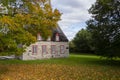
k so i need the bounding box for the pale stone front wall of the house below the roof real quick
[21,41,69,60]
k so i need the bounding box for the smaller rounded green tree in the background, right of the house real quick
[73,29,92,53]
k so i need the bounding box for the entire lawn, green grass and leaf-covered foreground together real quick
[0,54,120,80]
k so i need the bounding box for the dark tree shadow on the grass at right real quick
[72,57,120,67]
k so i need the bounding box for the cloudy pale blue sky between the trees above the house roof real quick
[51,0,96,40]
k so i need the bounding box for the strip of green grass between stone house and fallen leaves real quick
[0,54,120,66]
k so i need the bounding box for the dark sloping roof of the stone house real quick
[52,26,68,42]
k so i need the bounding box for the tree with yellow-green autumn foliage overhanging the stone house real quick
[0,0,61,55]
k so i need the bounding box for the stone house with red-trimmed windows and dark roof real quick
[21,26,69,60]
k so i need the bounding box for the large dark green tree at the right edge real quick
[87,0,120,58]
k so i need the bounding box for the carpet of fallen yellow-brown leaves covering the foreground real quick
[0,64,120,80]
